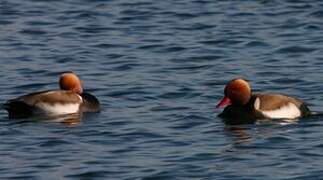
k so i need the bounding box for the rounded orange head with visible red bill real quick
[217,78,251,107]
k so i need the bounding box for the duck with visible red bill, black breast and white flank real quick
[217,78,310,124]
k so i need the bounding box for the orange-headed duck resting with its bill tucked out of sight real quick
[3,72,100,118]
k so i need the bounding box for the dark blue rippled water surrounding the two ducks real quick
[0,0,323,180]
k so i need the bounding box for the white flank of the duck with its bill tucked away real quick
[36,103,80,114]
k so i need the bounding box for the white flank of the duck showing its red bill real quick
[260,103,301,119]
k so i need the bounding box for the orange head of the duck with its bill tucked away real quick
[59,72,83,94]
